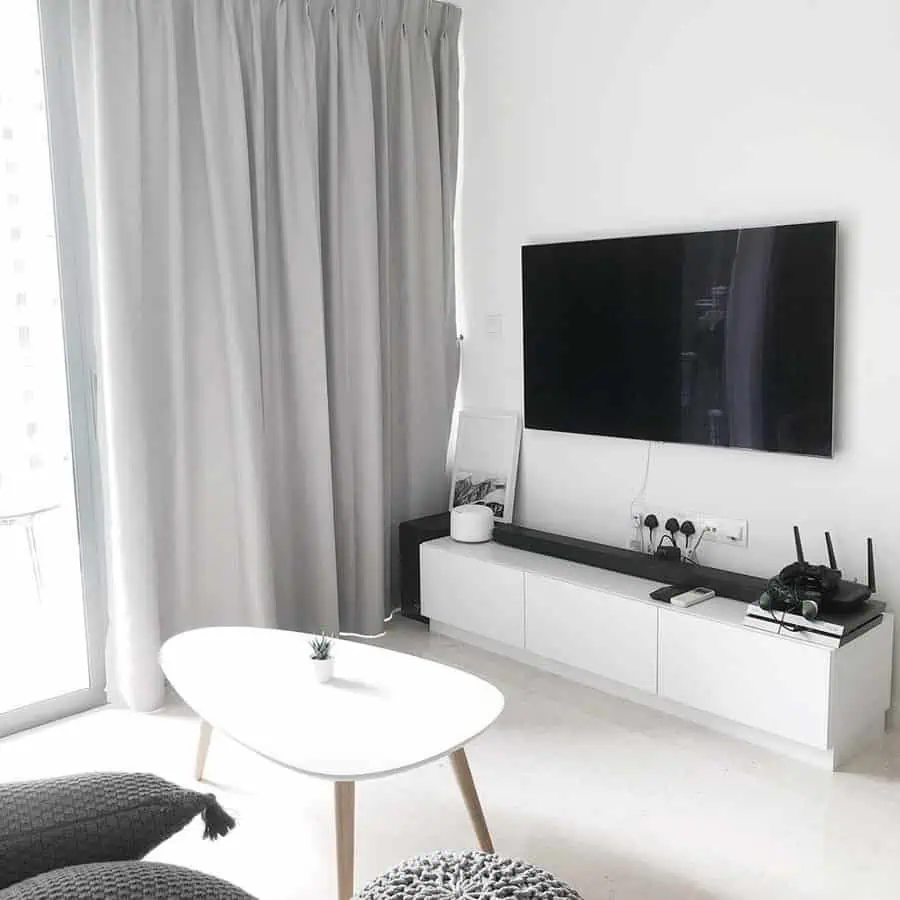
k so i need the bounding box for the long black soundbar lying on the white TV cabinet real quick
[494,523,766,603]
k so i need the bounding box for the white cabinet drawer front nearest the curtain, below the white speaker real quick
[420,544,525,648]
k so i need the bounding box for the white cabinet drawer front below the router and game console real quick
[659,610,831,749]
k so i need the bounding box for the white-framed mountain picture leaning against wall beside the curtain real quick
[450,409,522,522]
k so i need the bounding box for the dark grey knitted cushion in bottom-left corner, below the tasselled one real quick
[0,862,253,900]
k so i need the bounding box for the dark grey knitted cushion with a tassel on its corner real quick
[0,773,234,888]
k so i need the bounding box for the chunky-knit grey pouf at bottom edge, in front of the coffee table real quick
[356,850,581,900]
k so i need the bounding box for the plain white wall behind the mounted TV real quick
[460,0,900,704]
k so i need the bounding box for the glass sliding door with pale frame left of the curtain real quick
[0,0,104,734]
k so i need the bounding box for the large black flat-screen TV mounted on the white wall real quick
[522,222,837,456]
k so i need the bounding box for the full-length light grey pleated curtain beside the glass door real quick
[41,0,460,709]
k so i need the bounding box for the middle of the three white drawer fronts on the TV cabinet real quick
[525,574,657,694]
